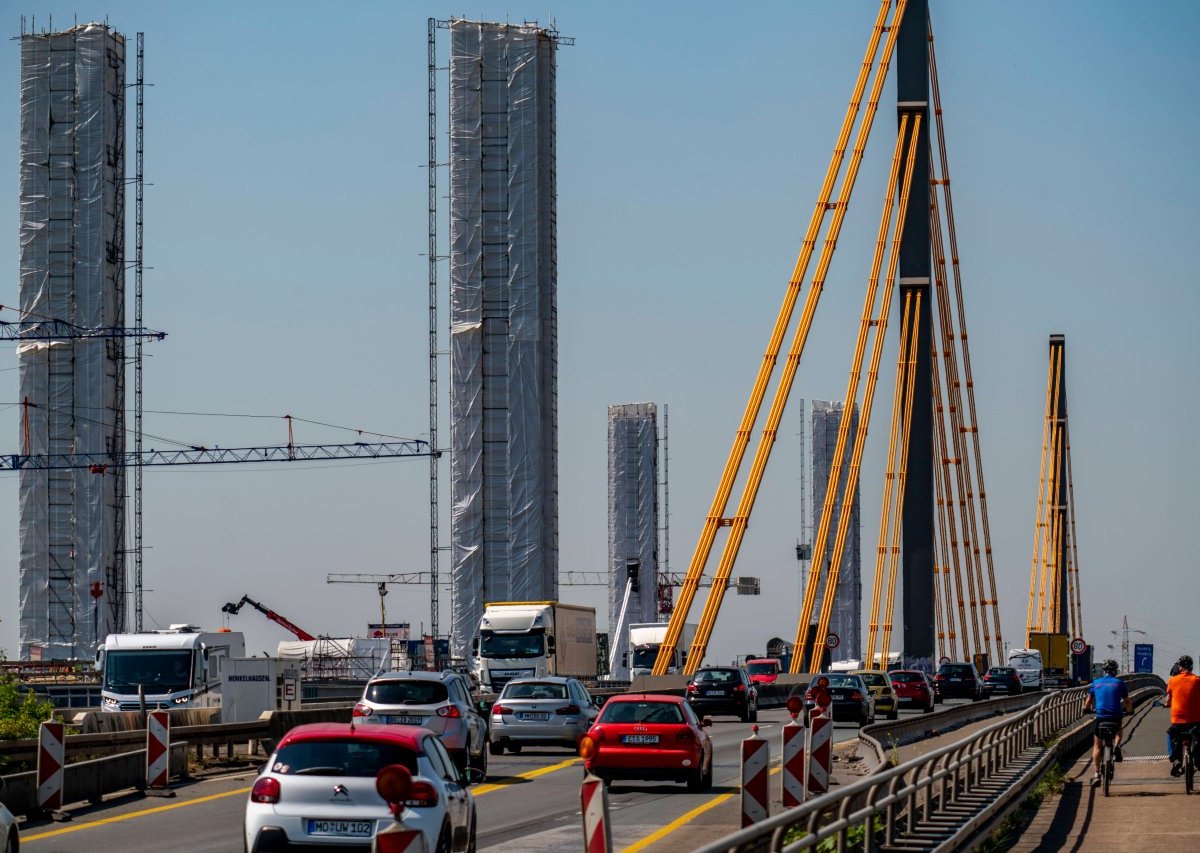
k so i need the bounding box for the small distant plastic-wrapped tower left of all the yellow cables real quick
[608,403,660,668]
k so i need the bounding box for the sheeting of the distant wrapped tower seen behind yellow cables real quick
[812,400,863,659]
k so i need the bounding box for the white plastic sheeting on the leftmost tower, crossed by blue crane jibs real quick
[17,24,125,659]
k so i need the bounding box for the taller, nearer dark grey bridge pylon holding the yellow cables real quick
[896,0,936,660]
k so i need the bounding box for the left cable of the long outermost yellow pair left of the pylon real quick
[654,0,899,675]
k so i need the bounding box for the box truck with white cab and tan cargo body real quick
[472,601,596,692]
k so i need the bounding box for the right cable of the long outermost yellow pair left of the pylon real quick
[676,0,906,675]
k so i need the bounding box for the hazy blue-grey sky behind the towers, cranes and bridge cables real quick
[0,0,1200,672]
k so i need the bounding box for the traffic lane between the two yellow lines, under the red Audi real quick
[475,709,806,851]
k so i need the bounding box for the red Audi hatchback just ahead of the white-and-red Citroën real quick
[580,693,713,791]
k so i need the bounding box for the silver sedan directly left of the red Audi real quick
[491,675,599,756]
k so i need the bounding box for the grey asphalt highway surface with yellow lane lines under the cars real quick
[14,709,960,853]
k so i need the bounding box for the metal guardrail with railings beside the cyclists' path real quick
[698,675,1165,853]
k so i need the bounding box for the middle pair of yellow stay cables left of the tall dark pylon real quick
[791,111,920,672]
